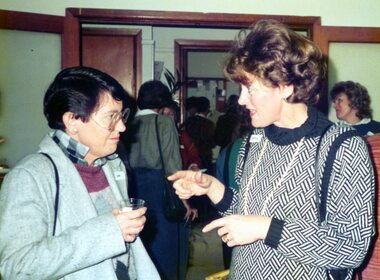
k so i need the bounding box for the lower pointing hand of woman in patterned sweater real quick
[202,215,272,247]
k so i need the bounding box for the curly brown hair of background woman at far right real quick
[330,81,372,119]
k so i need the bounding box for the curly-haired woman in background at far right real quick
[330,81,380,136]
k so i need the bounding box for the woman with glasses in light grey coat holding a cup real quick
[0,67,159,279]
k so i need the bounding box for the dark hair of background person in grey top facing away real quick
[137,80,173,109]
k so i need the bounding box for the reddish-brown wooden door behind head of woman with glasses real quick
[81,28,141,96]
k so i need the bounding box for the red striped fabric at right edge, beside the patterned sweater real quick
[356,134,380,280]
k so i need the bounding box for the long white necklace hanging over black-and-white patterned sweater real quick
[243,137,305,216]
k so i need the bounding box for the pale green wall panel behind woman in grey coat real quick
[0,29,61,166]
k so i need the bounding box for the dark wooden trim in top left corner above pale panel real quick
[0,10,64,34]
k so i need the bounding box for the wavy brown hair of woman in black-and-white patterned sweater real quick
[224,20,326,105]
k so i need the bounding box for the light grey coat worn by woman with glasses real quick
[0,135,159,280]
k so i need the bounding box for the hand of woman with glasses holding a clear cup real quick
[112,207,147,242]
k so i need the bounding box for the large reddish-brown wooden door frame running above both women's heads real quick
[62,8,321,104]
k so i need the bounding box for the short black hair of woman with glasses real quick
[44,66,131,130]
